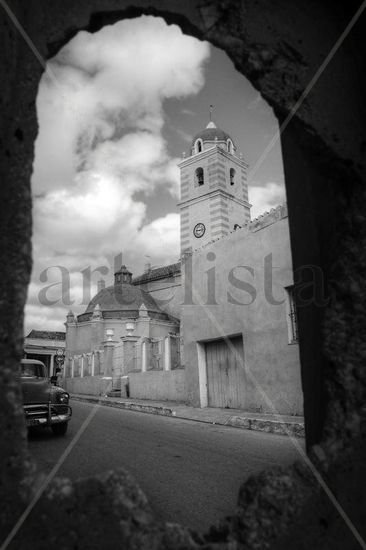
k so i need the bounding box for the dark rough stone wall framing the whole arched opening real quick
[0,0,366,548]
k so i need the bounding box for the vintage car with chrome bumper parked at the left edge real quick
[20,359,72,435]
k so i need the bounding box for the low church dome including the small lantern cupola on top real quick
[78,266,169,322]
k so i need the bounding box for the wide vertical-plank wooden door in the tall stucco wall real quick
[205,336,245,409]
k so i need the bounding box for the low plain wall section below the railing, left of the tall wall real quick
[128,369,186,401]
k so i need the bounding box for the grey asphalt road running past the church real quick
[29,401,303,531]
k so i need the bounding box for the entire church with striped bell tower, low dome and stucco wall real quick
[66,120,302,415]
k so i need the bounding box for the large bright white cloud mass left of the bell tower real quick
[26,17,209,330]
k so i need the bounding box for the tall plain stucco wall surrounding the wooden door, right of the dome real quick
[183,213,303,415]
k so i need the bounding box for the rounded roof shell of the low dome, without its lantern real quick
[85,284,162,316]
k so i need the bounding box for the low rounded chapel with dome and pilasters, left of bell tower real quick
[66,265,179,395]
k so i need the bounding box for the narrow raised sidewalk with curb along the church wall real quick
[70,394,305,437]
